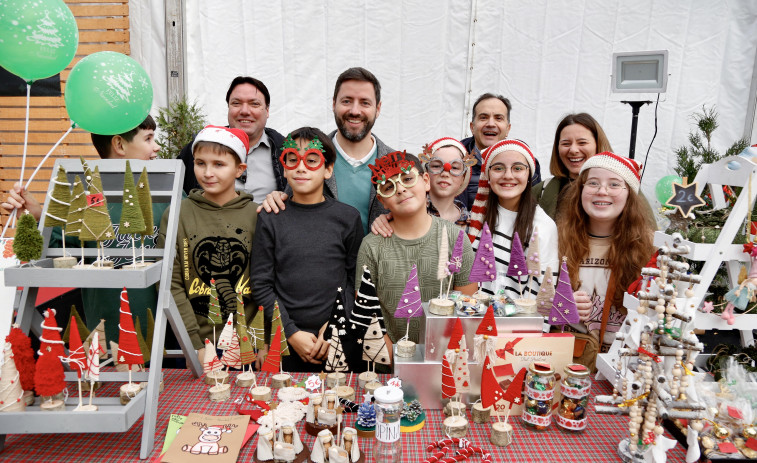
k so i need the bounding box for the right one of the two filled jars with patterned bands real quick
[555,363,591,431]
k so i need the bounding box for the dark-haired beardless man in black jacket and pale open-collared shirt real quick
[179,76,287,203]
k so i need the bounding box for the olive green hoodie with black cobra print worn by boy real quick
[160,189,258,349]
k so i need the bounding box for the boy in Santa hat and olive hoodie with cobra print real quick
[160,125,258,361]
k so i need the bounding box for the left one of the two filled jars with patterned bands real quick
[521,362,555,431]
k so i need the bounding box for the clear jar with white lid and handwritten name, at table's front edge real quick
[373,386,403,463]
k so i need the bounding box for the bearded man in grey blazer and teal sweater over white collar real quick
[258,67,394,234]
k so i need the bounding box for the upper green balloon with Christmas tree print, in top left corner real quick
[0,0,79,83]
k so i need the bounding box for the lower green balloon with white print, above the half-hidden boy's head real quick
[64,51,152,135]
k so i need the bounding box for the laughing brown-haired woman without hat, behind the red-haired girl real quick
[533,113,656,227]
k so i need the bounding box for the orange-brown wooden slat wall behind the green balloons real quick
[0,0,130,232]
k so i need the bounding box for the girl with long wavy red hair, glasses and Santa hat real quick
[557,152,654,370]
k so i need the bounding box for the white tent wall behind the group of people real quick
[129,0,757,205]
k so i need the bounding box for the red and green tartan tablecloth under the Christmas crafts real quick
[0,369,685,463]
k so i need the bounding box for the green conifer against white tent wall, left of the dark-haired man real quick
[156,97,205,159]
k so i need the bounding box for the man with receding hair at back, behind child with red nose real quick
[456,93,541,210]
